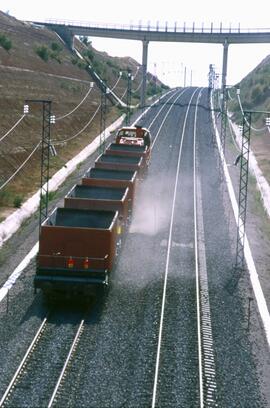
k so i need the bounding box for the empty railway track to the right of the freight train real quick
[151,89,218,408]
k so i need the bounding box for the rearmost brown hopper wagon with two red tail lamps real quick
[34,208,118,294]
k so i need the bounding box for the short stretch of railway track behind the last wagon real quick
[0,310,85,407]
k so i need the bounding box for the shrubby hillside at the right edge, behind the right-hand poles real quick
[228,55,270,183]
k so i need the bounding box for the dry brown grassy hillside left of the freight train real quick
[0,11,168,219]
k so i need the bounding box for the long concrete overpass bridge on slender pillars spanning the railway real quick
[34,20,270,106]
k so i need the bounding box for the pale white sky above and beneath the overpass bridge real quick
[0,0,270,87]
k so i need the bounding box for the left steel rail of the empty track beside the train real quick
[151,88,199,408]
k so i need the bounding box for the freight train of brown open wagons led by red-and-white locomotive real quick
[34,122,151,297]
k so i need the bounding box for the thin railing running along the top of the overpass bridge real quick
[41,19,270,34]
